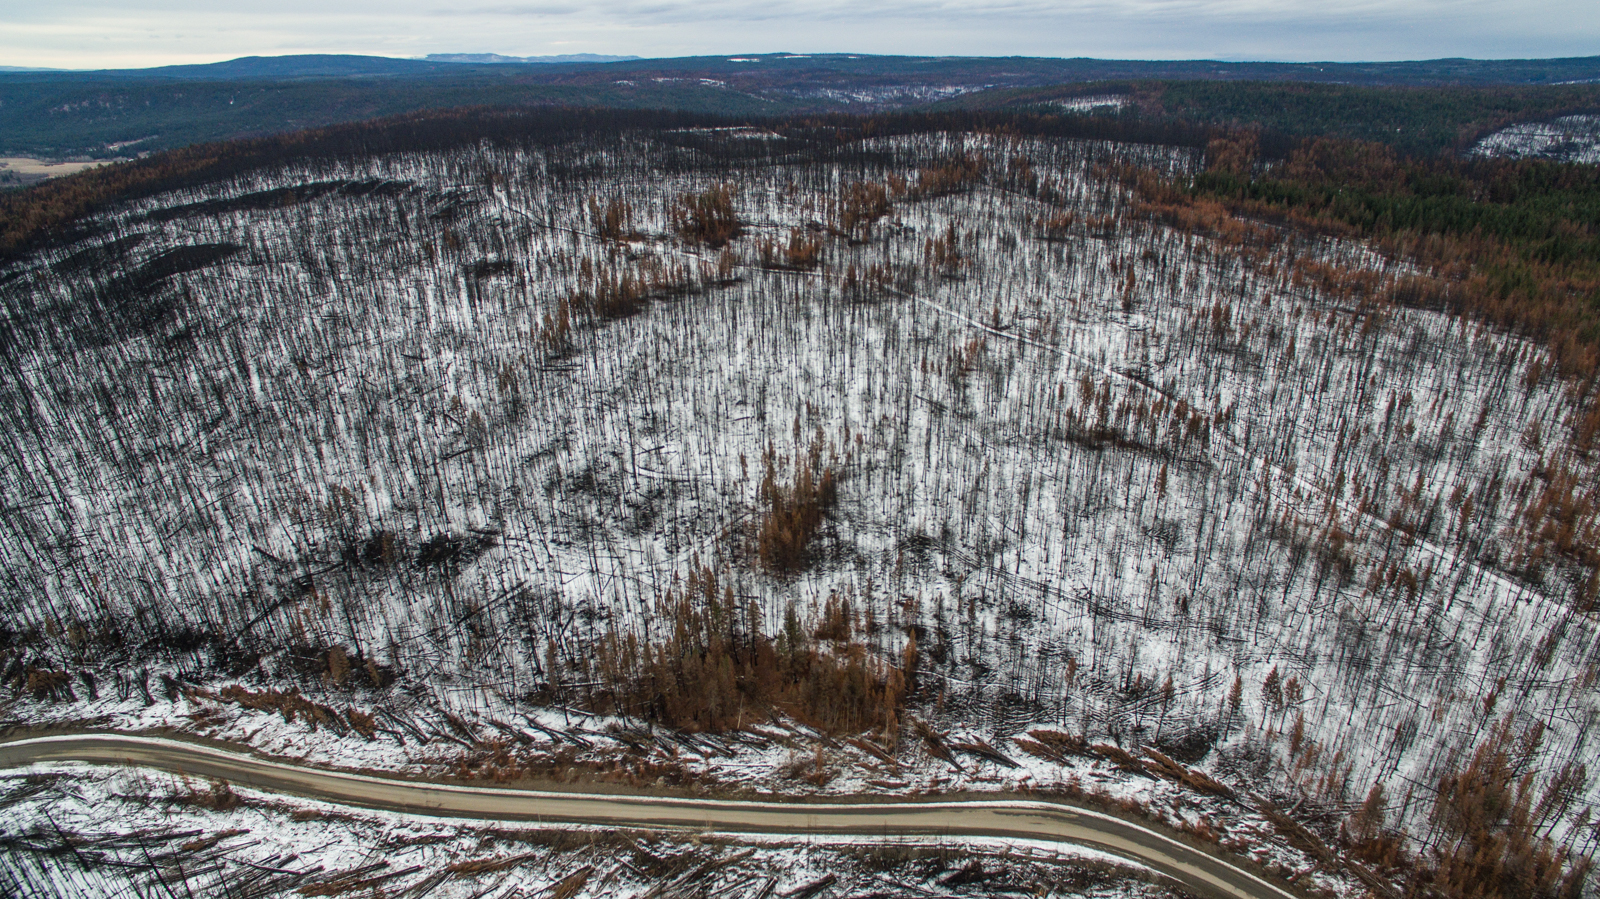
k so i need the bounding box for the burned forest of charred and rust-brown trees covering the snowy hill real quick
[0,114,1600,899]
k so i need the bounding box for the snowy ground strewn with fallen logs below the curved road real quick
[0,765,1181,899]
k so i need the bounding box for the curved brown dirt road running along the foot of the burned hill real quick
[0,734,1299,899]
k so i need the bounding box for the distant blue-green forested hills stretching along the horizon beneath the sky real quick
[9,53,1600,158]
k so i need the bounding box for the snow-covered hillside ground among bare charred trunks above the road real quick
[0,134,1600,889]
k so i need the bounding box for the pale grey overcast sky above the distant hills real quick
[0,0,1600,69]
